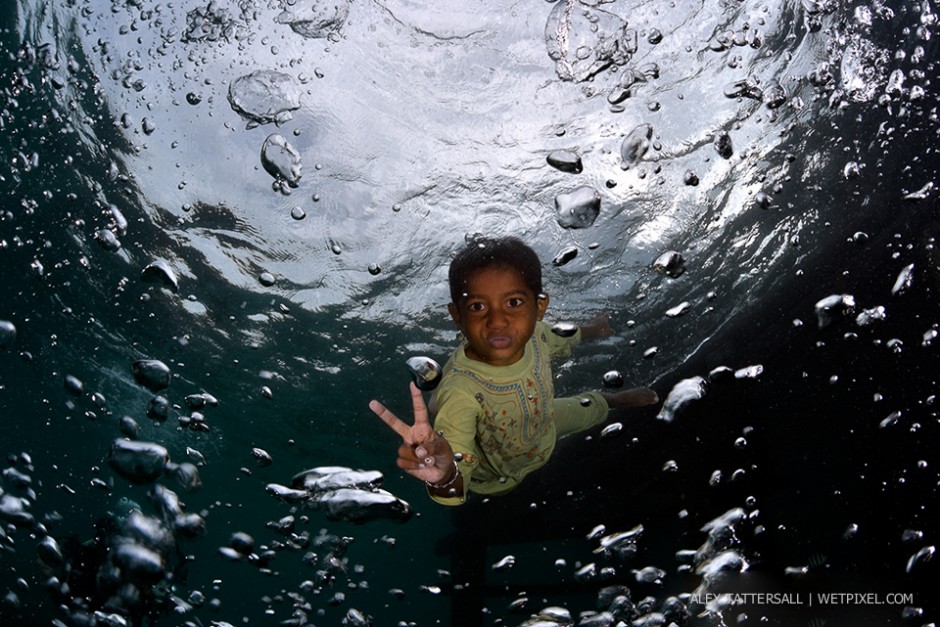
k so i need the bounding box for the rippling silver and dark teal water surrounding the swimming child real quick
[0,0,940,627]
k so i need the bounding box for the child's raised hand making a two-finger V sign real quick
[369,383,454,483]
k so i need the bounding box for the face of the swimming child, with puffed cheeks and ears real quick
[449,267,548,366]
